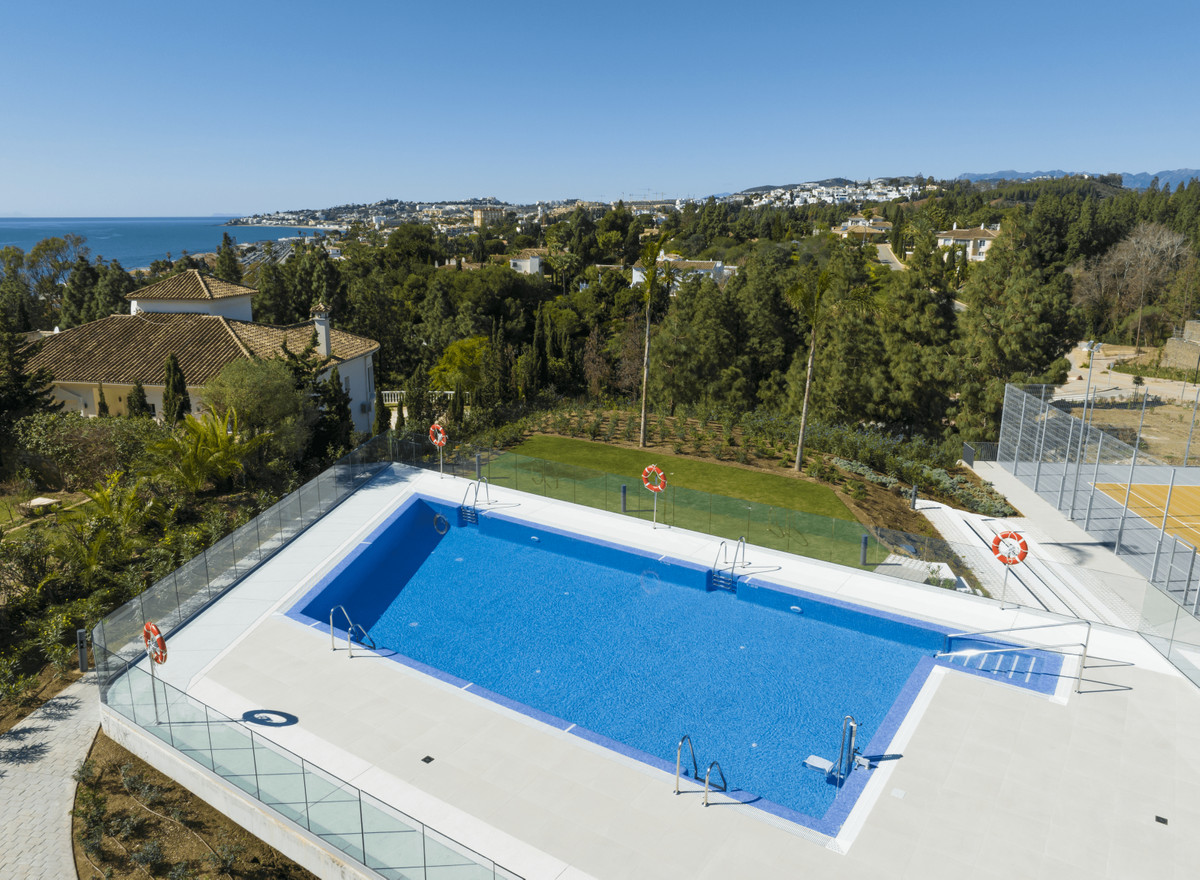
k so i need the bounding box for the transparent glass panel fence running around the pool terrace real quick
[92,424,1200,878]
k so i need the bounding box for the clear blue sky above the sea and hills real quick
[0,0,1200,216]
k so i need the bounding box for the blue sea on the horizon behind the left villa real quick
[0,217,338,269]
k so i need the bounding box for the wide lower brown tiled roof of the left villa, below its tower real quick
[26,313,379,385]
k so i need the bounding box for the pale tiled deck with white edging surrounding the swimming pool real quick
[108,466,1200,880]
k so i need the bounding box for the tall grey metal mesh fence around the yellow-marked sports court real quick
[996,385,1200,615]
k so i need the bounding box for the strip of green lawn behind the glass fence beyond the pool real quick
[512,435,857,522]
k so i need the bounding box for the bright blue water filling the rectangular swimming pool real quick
[293,497,1057,834]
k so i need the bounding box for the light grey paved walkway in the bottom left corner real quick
[0,672,100,880]
